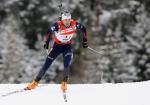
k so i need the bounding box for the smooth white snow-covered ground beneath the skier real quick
[0,81,150,105]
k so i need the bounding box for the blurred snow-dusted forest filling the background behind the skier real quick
[0,0,150,83]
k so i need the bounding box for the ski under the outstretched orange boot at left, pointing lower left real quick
[1,85,47,97]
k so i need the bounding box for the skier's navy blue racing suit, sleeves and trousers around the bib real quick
[35,19,87,82]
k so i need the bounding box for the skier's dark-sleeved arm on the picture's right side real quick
[76,22,88,48]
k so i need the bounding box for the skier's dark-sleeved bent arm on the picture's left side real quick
[44,22,58,49]
